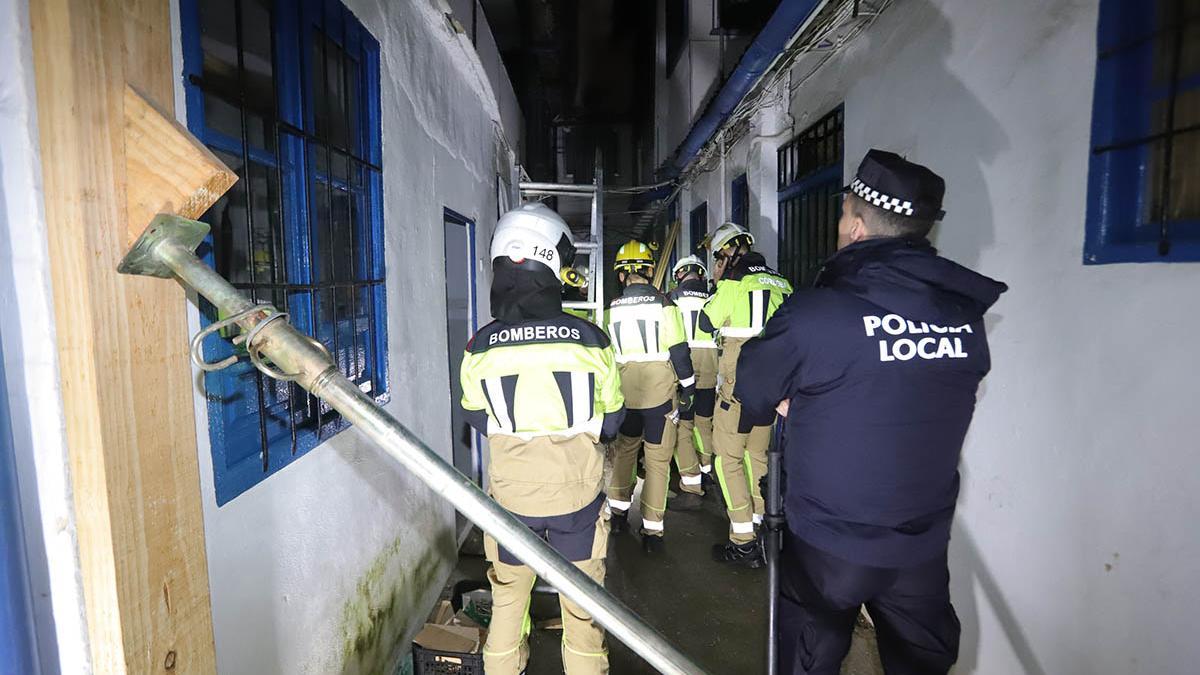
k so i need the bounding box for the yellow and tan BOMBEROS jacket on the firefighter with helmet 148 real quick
[461,313,624,516]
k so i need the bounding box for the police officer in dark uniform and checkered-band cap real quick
[734,150,1007,675]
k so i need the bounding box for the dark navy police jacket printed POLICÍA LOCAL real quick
[734,238,1008,567]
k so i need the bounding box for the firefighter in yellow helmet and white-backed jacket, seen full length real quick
[606,241,700,554]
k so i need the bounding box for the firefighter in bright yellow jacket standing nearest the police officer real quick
[698,222,792,567]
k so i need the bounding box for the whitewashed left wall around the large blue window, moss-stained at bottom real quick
[173,0,506,674]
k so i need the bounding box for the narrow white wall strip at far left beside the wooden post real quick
[0,0,91,674]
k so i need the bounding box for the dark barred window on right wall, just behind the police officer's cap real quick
[776,106,845,288]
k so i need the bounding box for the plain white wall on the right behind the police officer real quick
[667,0,1200,675]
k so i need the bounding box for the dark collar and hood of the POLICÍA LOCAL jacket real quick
[816,238,1008,325]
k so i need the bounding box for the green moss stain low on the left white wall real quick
[342,532,455,674]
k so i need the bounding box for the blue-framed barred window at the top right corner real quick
[1084,0,1200,264]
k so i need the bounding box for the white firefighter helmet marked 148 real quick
[492,202,575,276]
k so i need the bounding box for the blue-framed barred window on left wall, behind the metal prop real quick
[180,0,388,504]
